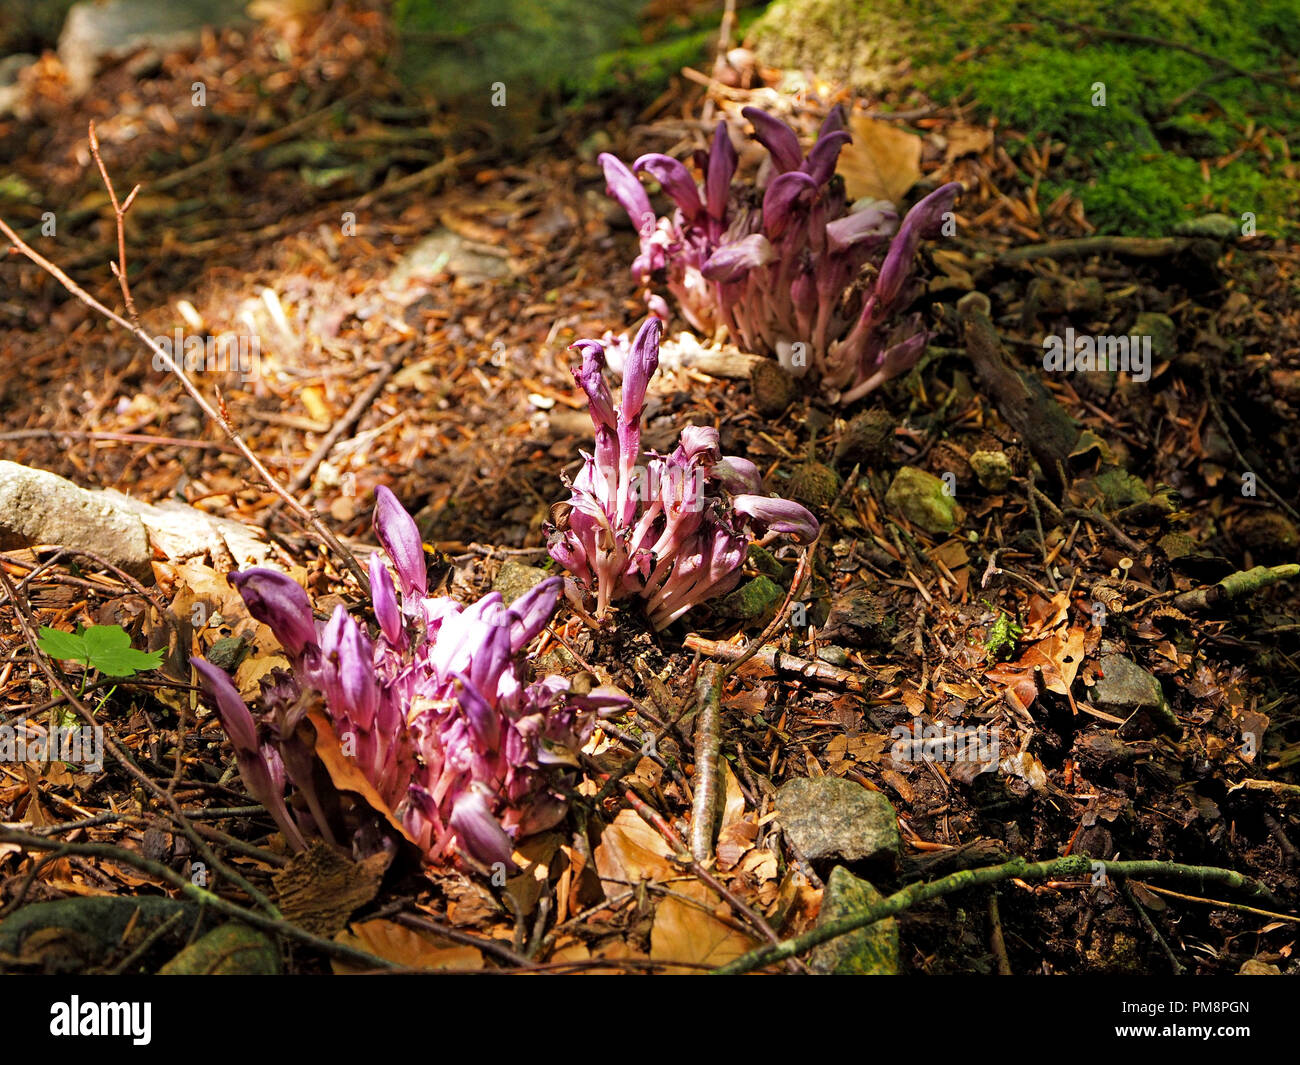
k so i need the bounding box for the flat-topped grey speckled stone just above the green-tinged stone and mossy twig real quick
[776,776,900,870]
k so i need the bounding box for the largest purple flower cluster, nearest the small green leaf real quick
[194,486,627,866]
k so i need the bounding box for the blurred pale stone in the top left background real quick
[59,0,247,94]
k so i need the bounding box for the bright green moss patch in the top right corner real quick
[754,0,1300,234]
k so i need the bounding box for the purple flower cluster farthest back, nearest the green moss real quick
[599,107,961,403]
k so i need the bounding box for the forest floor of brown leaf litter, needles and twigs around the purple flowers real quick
[0,6,1300,973]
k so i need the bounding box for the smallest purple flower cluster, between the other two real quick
[547,316,818,629]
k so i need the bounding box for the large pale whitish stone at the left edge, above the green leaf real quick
[0,462,153,584]
